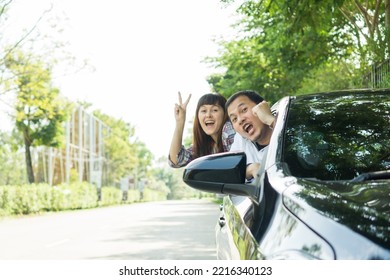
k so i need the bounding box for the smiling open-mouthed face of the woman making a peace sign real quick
[198,105,225,142]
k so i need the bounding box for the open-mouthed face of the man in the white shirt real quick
[227,96,264,142]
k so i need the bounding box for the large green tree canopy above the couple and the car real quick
[210,0,390,98]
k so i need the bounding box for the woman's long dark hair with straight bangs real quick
[192,93,228,159]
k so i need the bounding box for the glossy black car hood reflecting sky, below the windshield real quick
[283,180,390,259]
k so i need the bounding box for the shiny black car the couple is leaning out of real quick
[183,89,390,260]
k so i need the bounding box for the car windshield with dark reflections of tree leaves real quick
[283,91,390,180]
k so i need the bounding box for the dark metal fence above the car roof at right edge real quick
[363,59,390,88]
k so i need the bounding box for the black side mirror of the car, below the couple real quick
[183,152,258,197]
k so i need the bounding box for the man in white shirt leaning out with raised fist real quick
[225,90,276,179]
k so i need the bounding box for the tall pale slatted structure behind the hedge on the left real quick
[32,107,109,188]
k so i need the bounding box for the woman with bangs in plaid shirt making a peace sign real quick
[168,92,235,168]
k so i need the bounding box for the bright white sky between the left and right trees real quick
[1,0,239,159]
